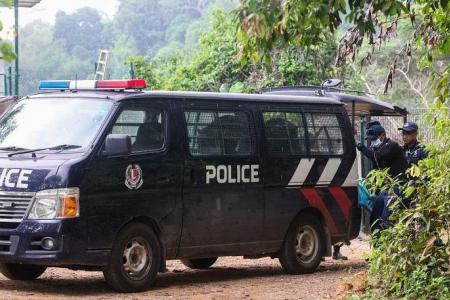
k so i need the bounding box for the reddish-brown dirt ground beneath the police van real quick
[0,240,369,300]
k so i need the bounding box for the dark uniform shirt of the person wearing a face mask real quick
[359,139,408,177]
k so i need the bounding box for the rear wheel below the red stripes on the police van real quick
[279,215,326,274]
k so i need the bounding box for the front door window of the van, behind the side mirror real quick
[112,107,165,152]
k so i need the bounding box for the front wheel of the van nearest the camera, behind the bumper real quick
[103,223,162,293]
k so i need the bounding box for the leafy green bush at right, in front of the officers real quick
[362,104,450,299]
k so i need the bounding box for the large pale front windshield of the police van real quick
[0,98,113,151]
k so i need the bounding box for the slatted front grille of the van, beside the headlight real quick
[0,192,34,223]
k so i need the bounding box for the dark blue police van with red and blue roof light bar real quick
[0,80,361,292]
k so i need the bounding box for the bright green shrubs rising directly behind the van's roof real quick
[128,11,335,92]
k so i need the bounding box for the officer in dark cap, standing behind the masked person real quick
[398,122,428,166]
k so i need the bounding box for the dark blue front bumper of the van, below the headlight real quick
[0,219,111,266]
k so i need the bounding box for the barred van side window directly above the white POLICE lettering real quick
[185,110,252,156]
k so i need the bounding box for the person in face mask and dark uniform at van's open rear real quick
[357,123,408,229]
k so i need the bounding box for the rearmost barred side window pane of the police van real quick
[305,113,344,155]
